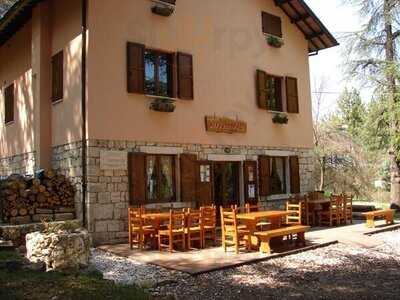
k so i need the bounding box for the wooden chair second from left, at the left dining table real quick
[158,210,186,252]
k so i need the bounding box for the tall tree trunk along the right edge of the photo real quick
[383,0,400,208]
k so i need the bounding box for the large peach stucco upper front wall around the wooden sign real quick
[88,0,312,147]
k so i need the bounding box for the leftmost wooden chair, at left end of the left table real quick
[128,207,156,250]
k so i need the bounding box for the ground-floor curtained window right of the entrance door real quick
[268,157,286,195]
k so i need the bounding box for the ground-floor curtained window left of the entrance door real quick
[146,155,175,203]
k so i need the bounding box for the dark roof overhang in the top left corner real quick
[0,0,42,46]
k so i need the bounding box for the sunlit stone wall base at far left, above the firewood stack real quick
[0,152,36,177]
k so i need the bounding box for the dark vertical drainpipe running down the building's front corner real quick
[81,0,87,227]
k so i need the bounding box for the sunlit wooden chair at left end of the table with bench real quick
[220,207,251,253]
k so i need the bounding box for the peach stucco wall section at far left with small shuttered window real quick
[0,22,34,157]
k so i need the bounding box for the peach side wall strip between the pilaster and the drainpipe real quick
[51,0,82,146]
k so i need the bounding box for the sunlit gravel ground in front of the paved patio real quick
[92,231,400,300]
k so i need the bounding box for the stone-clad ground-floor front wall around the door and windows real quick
[83,140,314,244]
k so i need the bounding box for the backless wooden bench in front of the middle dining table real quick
[254,225,310,254]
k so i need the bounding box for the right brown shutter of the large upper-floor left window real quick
[177,53,194,100]
